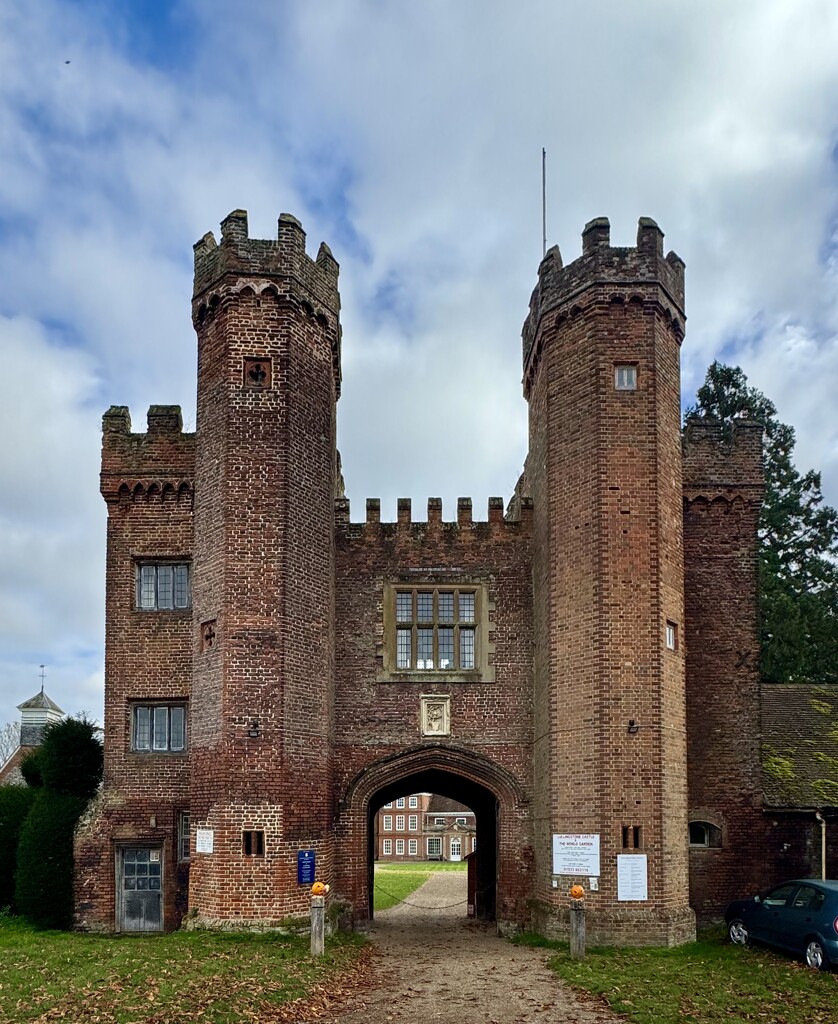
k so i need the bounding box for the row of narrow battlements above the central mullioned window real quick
[335,498,533,536]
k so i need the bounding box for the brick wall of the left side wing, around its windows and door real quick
[76,406,195,930]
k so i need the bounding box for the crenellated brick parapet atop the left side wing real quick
[100,406,196,501]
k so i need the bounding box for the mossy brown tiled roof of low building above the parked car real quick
[760,683,838,808]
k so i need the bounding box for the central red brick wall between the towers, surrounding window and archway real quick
[335,499,533,923]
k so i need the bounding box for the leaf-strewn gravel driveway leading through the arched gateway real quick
[323,871,622,1024]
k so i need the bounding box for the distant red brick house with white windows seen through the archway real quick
[375,793,477,861]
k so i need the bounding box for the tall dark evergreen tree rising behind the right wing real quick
[686,362,838,683]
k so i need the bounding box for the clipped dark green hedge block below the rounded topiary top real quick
[14,790,87,928]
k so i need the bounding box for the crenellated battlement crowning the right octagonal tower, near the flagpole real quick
[521,217,685,373]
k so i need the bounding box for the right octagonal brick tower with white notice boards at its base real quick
[523,218,695,943]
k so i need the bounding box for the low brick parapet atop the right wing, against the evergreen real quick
[681,417,764,497]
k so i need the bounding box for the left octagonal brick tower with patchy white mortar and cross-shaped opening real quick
[190,210,340,924]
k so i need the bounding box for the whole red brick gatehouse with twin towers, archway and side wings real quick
[76,211,767,943]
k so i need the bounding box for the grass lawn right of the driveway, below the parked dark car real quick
[520,930,838,1024]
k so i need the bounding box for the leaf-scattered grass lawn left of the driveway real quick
[0,916,369,1024]
